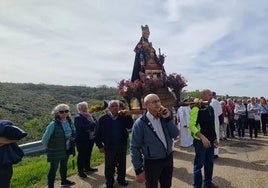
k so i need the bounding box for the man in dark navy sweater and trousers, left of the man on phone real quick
[94,100,133,188]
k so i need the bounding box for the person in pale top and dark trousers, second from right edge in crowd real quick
[247,97,260,139]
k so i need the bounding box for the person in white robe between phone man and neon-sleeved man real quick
[177,100,193,147]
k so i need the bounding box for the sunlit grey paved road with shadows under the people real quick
[44,132,268,188]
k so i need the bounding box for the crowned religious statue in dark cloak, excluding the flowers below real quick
[131,25,165,82]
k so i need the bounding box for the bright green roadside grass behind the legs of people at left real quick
[11,146,104,188]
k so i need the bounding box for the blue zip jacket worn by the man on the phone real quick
[130,114,179,174]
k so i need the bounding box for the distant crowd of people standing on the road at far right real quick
[218,97,268,140]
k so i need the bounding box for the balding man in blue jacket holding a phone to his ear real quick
[130,94,178,188]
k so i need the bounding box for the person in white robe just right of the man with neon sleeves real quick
[210,91,222,158]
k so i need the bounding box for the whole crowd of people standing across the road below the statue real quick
[0,89,268,188]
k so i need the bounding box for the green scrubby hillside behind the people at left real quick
[0,83,121,142]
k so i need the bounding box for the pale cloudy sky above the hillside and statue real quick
[0,0,268,97]
